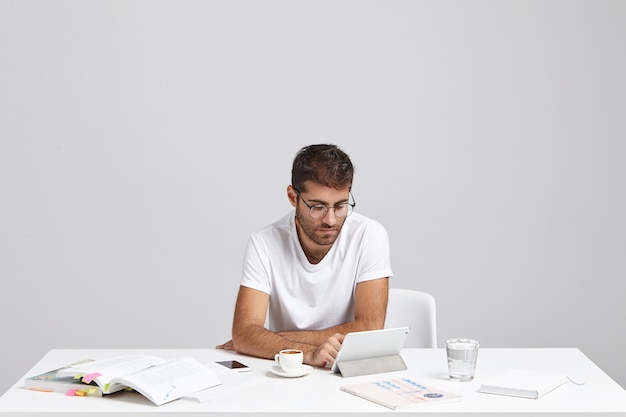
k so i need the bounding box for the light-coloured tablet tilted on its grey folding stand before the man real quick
[331,327,411,373]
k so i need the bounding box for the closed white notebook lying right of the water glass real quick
[478,369,567,399]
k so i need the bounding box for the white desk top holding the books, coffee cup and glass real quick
[0,348,626,417]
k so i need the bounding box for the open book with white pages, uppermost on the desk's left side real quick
[57,355,221,405]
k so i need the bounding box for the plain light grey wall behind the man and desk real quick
[0,0,626,392]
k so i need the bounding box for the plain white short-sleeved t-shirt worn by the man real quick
[241,210,393,331]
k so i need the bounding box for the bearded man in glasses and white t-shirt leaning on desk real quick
[217,145,392,367]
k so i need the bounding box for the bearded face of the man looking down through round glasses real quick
[295,181,350,246]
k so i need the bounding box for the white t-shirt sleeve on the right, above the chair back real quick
[357,220,393,282]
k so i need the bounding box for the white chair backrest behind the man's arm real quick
[385,288,437,348]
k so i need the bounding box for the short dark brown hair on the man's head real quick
[291,144,354,192]
